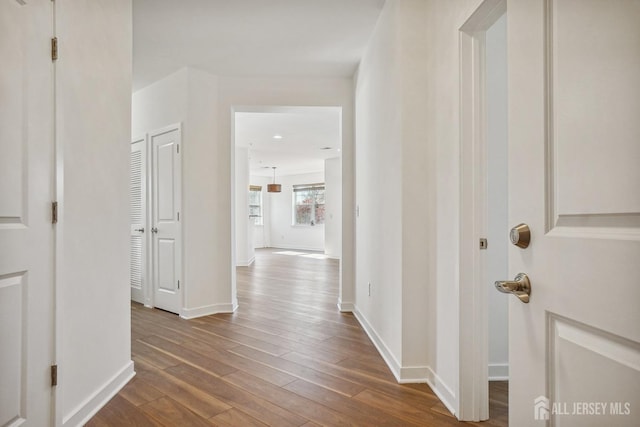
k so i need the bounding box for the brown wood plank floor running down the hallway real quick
[87,249,507,427]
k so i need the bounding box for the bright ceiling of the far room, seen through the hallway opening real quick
[235,107,342,177]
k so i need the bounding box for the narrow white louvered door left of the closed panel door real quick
[129,137,149,304]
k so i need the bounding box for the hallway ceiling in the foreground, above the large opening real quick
[133,0,384,90]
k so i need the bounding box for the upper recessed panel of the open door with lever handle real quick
[544,0,640,240]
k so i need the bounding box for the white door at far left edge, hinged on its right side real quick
[0,0,54,426]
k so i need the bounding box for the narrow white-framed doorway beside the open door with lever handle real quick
[459,0,509,421]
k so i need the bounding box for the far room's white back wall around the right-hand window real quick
[266,172,324,251]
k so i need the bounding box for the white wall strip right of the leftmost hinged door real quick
[55,0,133,426]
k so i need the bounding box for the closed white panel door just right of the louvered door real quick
[150,126,182,313]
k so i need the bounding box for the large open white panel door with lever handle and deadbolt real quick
[507,0,640,427]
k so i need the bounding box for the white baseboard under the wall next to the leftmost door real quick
[62,360,136,427]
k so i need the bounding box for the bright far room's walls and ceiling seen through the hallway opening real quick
[231,106,342,306]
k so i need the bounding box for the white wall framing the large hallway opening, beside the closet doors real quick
[133,72,354,317]
